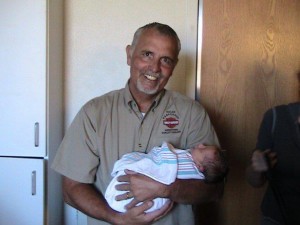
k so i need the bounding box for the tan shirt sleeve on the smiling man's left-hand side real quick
[52,104,99,183]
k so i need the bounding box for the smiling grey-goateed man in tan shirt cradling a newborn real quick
[53,23,223,225]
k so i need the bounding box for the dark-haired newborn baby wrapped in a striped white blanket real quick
[105,142,228,212]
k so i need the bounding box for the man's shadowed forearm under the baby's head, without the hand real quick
[164,179,224,204]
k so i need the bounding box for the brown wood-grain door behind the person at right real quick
[197,0,300,225]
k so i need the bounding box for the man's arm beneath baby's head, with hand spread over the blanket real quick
[116,171,224,204]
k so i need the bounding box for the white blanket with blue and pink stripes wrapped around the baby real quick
[105,142,204,212]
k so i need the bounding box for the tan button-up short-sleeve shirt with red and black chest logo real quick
[52,84,219,225]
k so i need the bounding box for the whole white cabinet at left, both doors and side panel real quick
[0,0,64,225]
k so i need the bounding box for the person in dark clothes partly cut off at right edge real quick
[246,73,300,225]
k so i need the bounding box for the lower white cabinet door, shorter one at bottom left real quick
[0,157,44,225]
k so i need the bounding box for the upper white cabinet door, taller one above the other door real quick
[0,0,47,157]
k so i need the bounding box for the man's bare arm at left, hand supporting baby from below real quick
[63,177,169,225]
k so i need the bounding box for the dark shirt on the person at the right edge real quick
[256,102,300,225]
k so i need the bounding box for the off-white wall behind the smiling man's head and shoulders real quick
[65,0,198,225]
